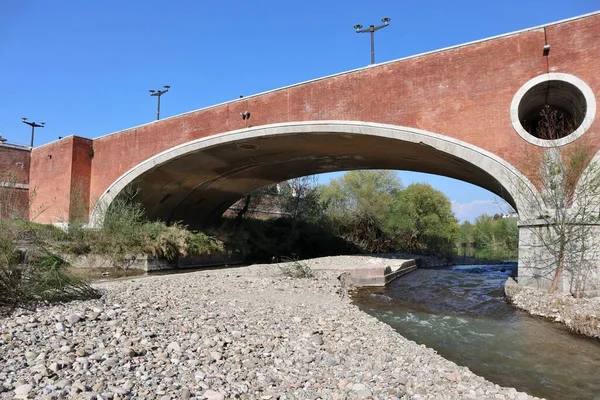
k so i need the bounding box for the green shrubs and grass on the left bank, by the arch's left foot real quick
[0,193,224,314]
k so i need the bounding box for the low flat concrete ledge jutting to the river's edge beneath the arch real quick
[310,256,417,286]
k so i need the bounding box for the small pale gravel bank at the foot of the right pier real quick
[504,279,600,339]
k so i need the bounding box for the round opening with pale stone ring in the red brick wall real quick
[511,73,596,147]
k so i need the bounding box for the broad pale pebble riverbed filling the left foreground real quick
[0,258,532,400]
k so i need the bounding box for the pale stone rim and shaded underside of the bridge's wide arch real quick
[90,121,539,227]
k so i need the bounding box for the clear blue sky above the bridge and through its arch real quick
[0,0,600,219]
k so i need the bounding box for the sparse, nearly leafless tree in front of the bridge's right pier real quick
[521,107,600,297]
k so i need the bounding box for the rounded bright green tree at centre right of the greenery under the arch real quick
[386,183,459,254]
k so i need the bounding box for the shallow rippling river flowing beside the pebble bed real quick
[353,264,600,399]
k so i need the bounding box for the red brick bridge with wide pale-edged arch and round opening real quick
[16,13,600,294]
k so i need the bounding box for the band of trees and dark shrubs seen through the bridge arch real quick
[227,170,518,262]
